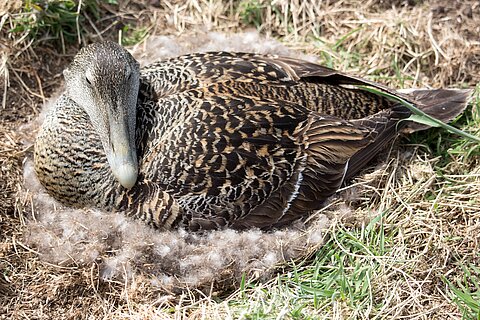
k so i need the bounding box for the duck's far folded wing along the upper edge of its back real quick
[140,52,408,120]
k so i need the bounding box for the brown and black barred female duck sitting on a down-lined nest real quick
[35,41,469,231]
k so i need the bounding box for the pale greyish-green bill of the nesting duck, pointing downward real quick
[108,124,138,189]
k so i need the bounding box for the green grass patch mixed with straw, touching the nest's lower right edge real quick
[228,215,400,319]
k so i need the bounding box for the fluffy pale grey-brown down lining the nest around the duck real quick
[20,33,328,290]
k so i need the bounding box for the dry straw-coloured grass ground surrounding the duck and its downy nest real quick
[0,0,480,319]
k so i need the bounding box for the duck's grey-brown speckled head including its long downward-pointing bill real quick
[63,41,140,189]
